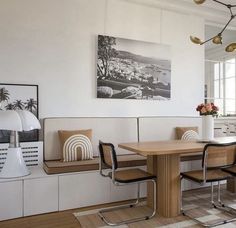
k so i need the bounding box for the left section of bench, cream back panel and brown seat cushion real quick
[44,118,146,174]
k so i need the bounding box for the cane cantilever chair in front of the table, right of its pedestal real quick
[181,142,236,227]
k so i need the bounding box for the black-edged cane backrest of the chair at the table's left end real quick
[99,141,118,169]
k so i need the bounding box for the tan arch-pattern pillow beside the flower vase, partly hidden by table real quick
[176,127,199,140]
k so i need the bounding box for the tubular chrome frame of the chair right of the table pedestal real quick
[180,142,236,227]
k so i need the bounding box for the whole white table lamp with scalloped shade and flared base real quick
[0,110,41,178]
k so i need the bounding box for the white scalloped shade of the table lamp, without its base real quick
[0,110,41,131]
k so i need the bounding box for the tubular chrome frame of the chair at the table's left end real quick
[98,142,156,226]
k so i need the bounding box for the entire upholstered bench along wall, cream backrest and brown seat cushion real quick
[44,117,205,174]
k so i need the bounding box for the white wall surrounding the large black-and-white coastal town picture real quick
[0,0,204,118]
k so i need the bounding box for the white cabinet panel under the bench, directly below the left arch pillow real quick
[59,171,110,211]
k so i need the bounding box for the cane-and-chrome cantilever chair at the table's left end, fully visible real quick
[98,141,156,226]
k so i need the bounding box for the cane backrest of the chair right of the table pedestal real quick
[202,142,236,169]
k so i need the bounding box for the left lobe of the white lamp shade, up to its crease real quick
[0,110,23,131]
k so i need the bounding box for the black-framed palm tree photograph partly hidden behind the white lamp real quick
[0,83,38,143]
